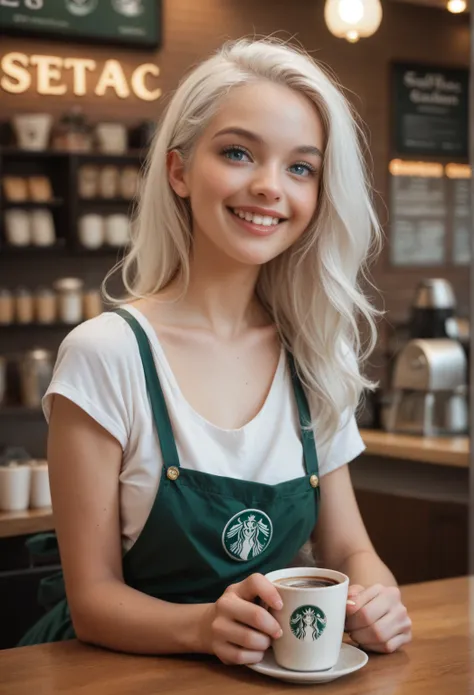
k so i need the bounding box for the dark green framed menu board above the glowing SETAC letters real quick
[0,0,161,48]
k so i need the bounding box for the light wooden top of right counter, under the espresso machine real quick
[360,429,469,468]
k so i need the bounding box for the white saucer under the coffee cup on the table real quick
[248,643,369,683]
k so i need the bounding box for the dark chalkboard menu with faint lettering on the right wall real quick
[392,63,469,159]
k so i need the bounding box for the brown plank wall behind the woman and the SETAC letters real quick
[0,0,469,320]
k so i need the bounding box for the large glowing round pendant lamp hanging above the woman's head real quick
[324,0,384,43]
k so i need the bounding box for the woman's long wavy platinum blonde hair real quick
[106,39,380,439]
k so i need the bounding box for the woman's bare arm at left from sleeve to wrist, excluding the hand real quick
[48,396,209,654]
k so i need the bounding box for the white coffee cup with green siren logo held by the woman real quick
[266,567,349,671]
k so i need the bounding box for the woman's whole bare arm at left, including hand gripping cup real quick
[48,396,280,664]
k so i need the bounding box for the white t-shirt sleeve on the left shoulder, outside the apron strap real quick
[43,314,133,449]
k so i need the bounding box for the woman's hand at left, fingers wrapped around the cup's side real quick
[202,574,283,664]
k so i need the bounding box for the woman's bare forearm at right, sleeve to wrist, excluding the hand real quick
[313,466,397,586]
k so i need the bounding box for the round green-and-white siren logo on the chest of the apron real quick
[222,509,273,562]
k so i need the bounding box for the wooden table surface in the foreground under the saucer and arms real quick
[0,577,474,695]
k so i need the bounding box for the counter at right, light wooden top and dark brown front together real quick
[349,429,469,584]
